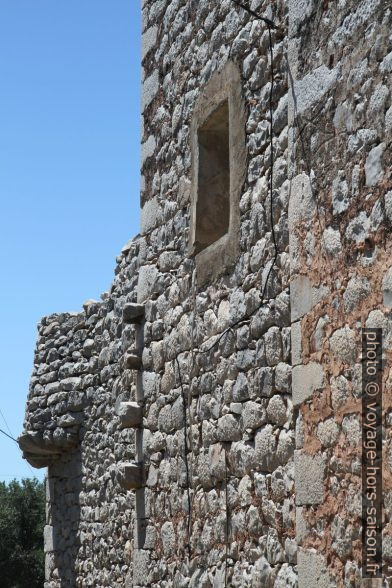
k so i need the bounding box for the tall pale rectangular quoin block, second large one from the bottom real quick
[294,450,325,506]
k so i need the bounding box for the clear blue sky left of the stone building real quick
[0,0,141,481]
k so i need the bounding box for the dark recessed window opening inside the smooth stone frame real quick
[194,100,230,253]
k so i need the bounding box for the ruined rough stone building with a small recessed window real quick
[19,0,392,588]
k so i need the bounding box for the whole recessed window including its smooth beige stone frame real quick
[189,62,246,285]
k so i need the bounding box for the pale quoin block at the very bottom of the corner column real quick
[297,548,336,588]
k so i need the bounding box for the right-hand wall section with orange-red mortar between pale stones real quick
[288,0,392,588]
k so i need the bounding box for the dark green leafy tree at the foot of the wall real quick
[0,479,45,588]
